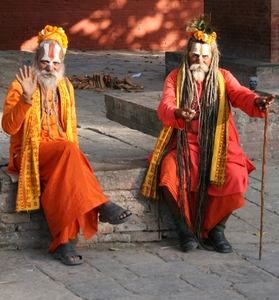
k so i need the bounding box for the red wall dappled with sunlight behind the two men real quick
[0,0,203,51]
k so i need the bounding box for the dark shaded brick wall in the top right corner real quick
[204,0,279,63]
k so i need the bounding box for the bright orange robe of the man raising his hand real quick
[2,80,108,252]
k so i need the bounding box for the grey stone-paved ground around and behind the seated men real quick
[0,51,279,300]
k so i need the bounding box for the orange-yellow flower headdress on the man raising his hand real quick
[38,25,68,54]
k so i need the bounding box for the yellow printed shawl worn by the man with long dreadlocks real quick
[141,68,229,199]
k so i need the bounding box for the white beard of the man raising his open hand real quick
[35,64,65,90]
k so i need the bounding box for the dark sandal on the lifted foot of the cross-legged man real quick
[99,203,133,225]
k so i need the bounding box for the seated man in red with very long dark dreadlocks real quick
[142,15,274,253]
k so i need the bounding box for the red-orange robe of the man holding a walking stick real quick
[158,69,264,236]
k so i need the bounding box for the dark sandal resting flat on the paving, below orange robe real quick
[52,243,83,266]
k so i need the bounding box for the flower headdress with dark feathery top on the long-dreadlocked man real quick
[186,15,217,44]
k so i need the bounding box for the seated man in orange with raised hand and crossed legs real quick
[2,25,132,265]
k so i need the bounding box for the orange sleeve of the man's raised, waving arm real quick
[2,80,31,135]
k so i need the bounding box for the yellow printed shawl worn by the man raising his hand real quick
[16,78,73,212]
